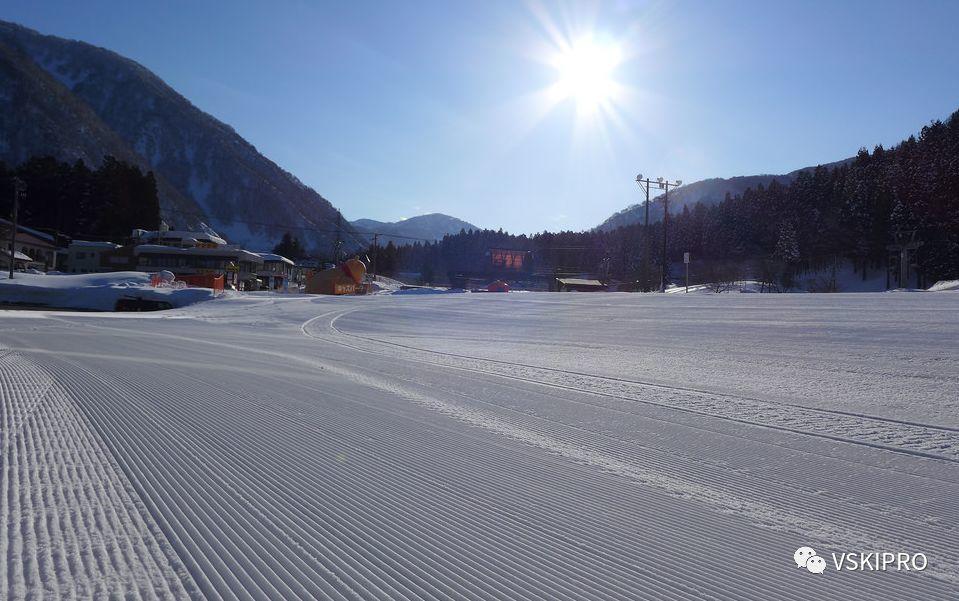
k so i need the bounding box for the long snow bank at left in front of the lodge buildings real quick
[0,271,213,311]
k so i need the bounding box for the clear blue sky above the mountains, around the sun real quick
[0,0,959,232]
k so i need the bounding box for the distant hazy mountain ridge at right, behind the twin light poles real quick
[596,159,852,231]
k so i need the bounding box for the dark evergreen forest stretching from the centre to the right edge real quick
[367,111,959,288]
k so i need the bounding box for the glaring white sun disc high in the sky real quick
[552,38,623,112]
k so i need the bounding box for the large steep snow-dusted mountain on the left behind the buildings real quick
[0,21,361,249]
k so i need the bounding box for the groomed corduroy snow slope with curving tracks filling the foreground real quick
[0,293,959,601]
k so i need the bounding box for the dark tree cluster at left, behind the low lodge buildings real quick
[0,156,160,241]
